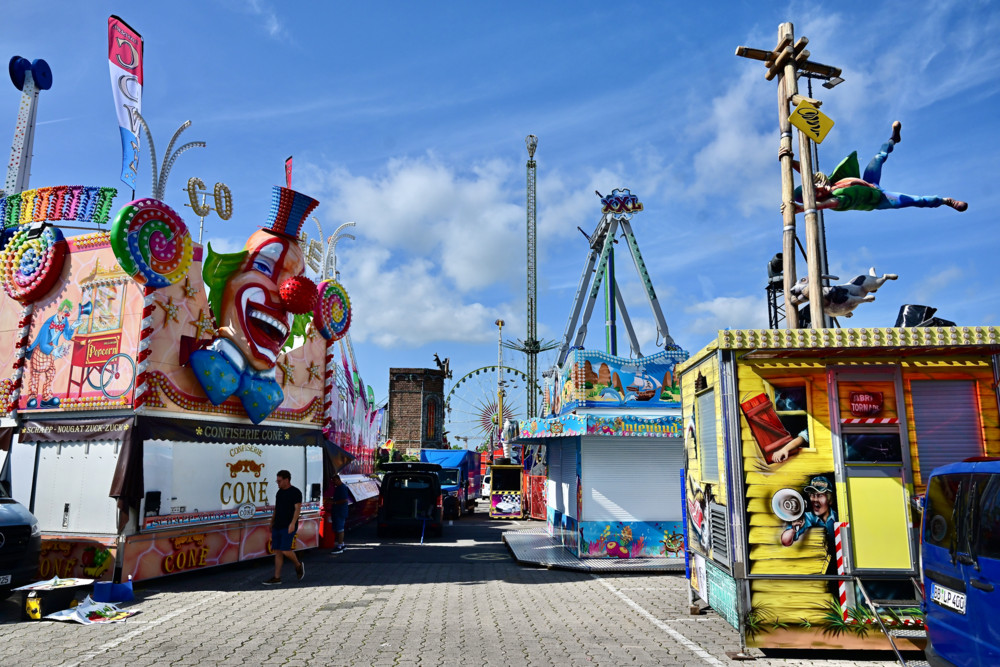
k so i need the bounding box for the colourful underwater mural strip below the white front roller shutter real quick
[580,521,684,558]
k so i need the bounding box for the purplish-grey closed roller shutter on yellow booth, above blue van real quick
[910,380,983,481]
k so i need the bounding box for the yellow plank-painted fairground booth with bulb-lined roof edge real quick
[678,327,1000,649]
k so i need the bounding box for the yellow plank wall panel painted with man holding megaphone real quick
[736,372,920,646]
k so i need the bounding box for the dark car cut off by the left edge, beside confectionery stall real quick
[0,483,42,599]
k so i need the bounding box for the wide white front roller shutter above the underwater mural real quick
[583,438,684,521]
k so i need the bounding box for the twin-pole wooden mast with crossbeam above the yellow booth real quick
[736,23,841,329]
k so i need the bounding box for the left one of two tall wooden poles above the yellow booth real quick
[778,23,799,329]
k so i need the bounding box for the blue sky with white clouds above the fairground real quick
[7,0,1000,422]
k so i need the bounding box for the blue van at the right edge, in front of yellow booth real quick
[921,457,1000,667]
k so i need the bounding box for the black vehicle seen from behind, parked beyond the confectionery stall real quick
[376,462,443,537]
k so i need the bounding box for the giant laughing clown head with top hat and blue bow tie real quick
[189,186,319,424]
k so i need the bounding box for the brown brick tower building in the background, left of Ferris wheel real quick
[388,368,447,450]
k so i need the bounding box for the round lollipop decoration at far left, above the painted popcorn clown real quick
[0,225,67,305]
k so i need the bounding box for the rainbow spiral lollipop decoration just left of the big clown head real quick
[111,199,194,289]
